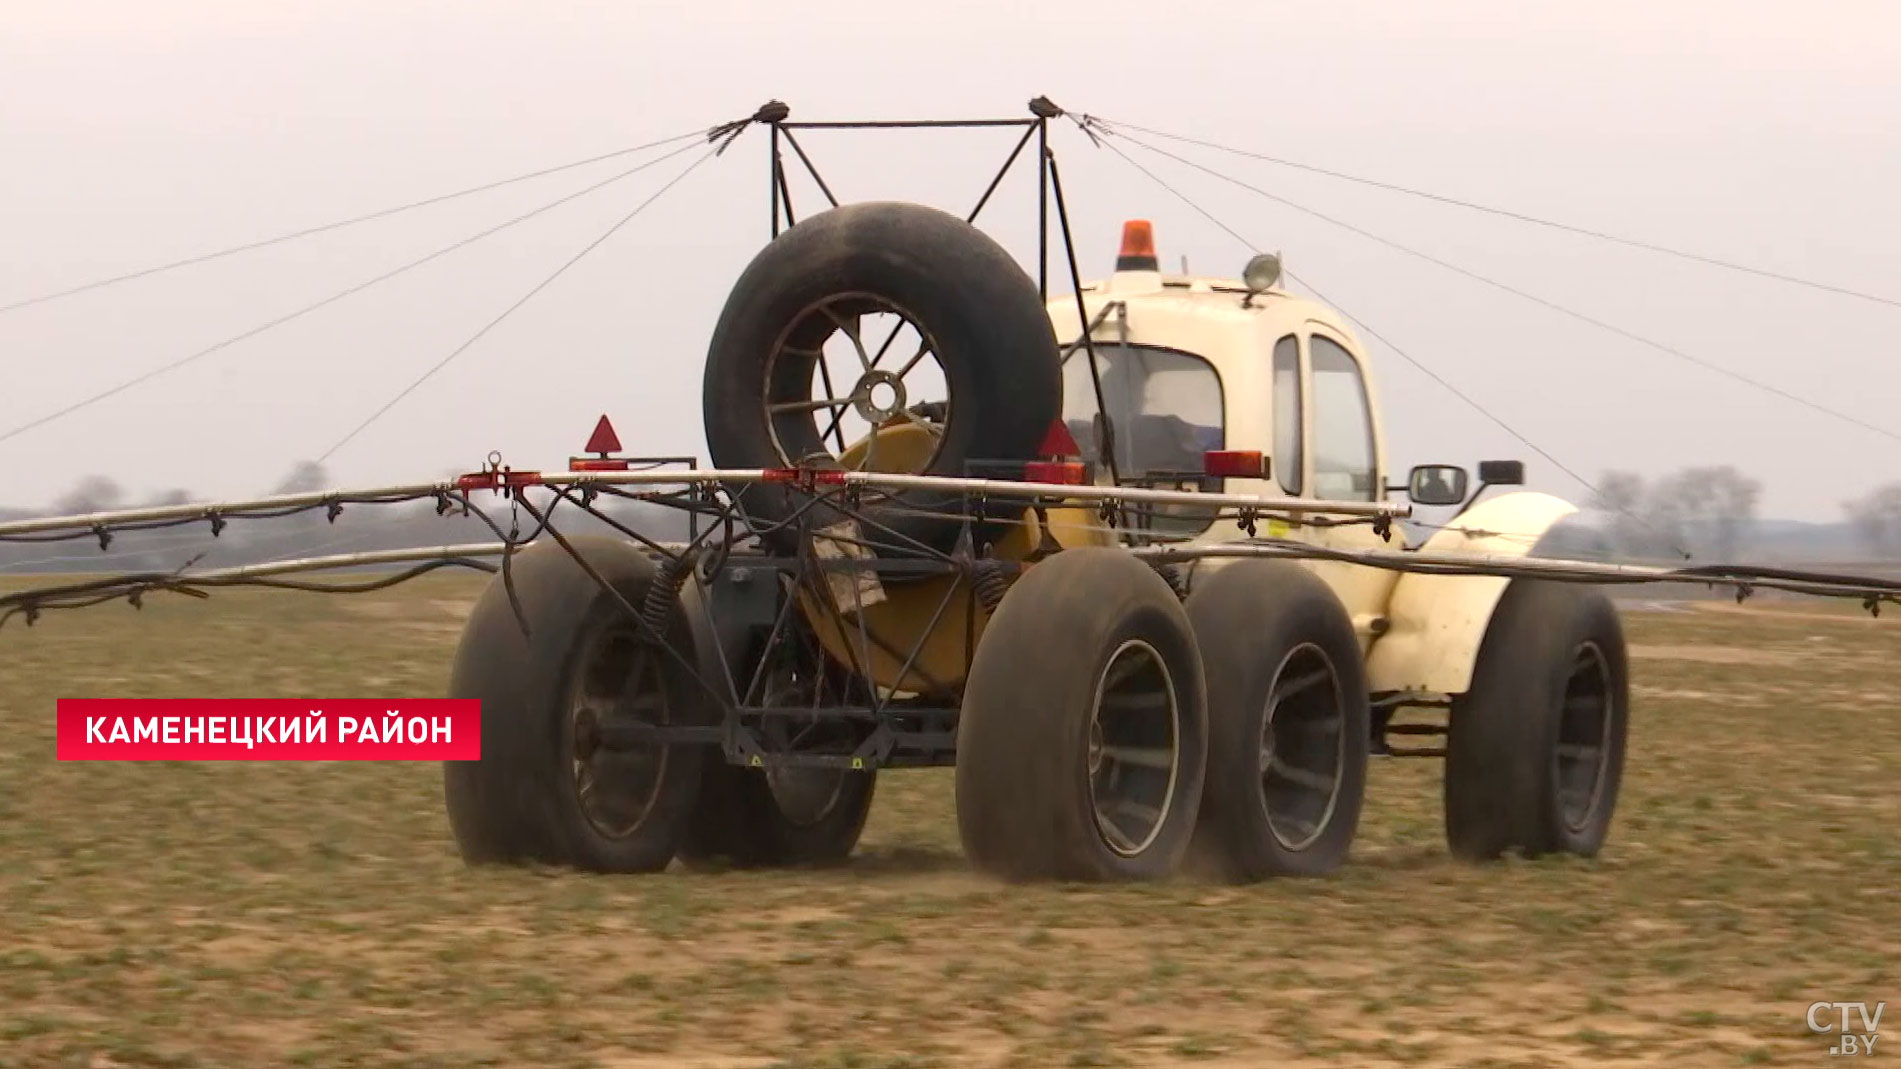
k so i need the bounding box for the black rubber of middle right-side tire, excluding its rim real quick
[1186,561,1371,881]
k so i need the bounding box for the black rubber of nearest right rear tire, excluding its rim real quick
[956,548,1207,881]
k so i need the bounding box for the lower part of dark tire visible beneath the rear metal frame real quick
[681,755,876,867]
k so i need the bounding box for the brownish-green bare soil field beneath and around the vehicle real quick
[0,578,1901,1069]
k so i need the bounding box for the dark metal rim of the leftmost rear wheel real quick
[568,626,671,839]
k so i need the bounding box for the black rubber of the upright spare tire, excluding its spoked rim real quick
[703,202,1063,550]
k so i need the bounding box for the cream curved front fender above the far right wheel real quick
[1367,491,1578,694]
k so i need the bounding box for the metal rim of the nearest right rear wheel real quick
[1087,639,1181,858]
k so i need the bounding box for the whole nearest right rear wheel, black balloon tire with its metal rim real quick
[956,548,1207,881]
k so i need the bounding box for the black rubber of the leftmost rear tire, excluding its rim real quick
[443,536,707,873]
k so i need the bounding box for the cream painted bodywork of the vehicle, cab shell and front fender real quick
[1047,272,1576,694]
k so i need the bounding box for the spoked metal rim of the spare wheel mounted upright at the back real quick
[764,293,954,474]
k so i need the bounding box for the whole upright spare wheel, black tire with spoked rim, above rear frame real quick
[703,202,1063,550]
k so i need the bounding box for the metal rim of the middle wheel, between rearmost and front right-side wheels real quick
[1260,643,1346,852]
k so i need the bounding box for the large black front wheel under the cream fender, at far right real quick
[1445,580,1631,860]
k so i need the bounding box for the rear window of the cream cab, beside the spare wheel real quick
[1063,344,1226,479]
